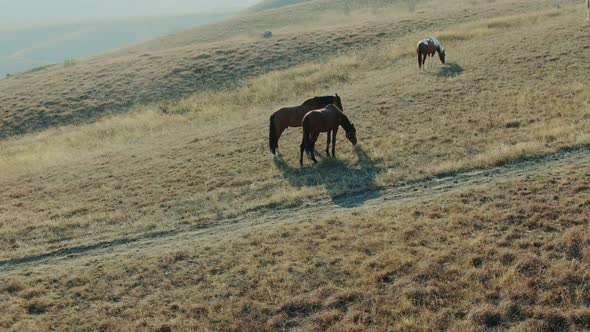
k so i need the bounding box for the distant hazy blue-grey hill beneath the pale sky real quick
[0,10,235,77]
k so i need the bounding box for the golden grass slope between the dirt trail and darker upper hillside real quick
[0,3,590,258]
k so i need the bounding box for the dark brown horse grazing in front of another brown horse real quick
[299,105,356,166]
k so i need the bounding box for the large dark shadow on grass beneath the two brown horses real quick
[274,146,381,208]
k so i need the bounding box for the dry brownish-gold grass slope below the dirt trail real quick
[0,152,590,331]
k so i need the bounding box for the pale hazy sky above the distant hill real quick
[0,0,259,26]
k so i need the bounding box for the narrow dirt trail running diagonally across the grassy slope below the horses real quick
[0,146,590,273]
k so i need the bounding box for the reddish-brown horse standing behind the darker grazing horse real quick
[268,94,343,155]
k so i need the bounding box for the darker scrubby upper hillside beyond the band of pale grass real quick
[0,1,560,137]
